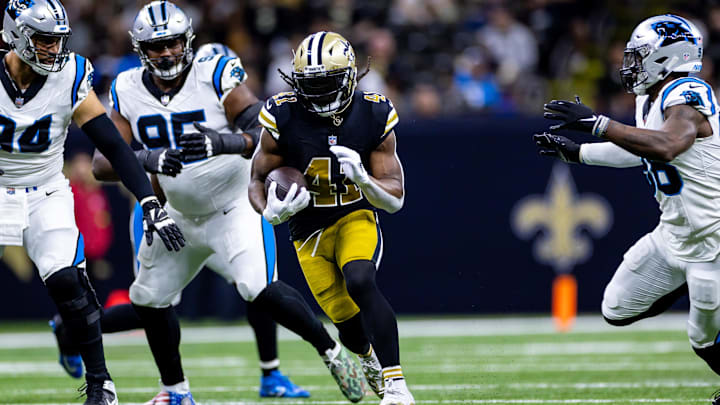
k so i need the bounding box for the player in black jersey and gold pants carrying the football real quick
[249,31,414,405]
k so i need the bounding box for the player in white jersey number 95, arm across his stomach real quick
[95,1,364,405]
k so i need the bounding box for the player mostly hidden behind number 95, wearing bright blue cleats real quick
[50,43,310,398]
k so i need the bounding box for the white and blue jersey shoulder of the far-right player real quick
[660,77,717,116]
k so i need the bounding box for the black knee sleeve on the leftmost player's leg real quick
[45,267,101,344]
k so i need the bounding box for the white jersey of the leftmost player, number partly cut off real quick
[0,53,93,187]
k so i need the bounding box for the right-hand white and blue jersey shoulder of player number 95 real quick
[193,55,247,102]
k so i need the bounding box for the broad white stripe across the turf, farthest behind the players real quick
[0,314,687,349]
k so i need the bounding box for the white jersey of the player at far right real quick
[635,77,720,262]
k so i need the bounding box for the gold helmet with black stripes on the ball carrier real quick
[280,31,357,117]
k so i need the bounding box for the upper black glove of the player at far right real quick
[543,96,610,137]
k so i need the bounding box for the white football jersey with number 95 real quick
[110,55,250,216]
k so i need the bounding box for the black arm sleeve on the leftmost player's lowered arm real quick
[82,114,153,201]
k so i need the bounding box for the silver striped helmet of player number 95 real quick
[129,1,195,80]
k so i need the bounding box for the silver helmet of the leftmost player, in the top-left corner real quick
[2,0,71,75]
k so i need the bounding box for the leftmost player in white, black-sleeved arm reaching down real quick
[0,0,184,405]
